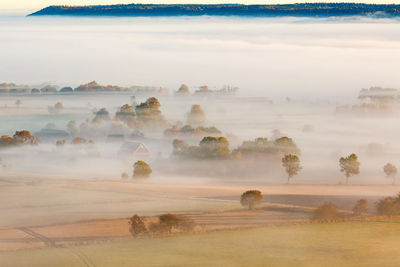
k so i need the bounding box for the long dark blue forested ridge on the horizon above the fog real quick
[29,3,400,17]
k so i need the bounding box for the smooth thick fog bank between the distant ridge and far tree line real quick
[0,16,400,100]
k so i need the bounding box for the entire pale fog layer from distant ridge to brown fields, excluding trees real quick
[0,16,400,184]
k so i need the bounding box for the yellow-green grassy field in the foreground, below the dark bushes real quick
[0,220,400,267]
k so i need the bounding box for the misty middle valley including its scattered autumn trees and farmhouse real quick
[0,82,400,184]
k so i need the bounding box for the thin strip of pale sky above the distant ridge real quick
[0,0,400,9]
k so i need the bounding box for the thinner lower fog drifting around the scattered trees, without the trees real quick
[0,90,400,184]
